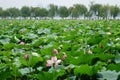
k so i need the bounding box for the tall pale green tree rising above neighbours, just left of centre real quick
[48,4,58,19]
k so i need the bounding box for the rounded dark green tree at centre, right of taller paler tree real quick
[58,6,69,18]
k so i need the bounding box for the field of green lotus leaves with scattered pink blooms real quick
[0,20,120,80]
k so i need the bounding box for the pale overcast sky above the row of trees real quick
[0,0,120,9]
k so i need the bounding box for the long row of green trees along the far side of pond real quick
[0,3,120,19]
